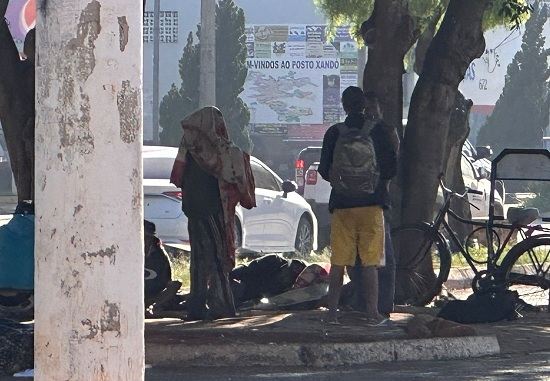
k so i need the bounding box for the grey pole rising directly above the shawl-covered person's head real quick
[199,0,216,107]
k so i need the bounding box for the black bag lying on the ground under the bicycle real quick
[437,290,518,324]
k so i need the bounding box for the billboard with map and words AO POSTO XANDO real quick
[245,24,358,140]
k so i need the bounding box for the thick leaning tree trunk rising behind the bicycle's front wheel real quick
[396,0,486,302]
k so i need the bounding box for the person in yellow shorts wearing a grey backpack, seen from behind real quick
[318,86,397,326]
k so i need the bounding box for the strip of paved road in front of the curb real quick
[145,352,550,381]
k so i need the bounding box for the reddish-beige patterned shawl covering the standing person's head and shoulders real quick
[170,106,256,269]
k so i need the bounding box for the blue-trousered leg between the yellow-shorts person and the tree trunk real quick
[378,221,396,317]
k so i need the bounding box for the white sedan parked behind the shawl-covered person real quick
[143,146,317,256]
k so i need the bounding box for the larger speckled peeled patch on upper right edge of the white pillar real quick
[117,81,141,143]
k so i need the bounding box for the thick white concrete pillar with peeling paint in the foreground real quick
[35,0,144,381]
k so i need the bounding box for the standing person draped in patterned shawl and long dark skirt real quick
[170,107,256,320]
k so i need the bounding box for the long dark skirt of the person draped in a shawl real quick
[187,212,235,320]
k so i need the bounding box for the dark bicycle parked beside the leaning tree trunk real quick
[391,176,550,306]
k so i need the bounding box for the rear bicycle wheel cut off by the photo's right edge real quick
[499,236,550,310]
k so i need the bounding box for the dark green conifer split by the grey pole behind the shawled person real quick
[159,0,252,152]
